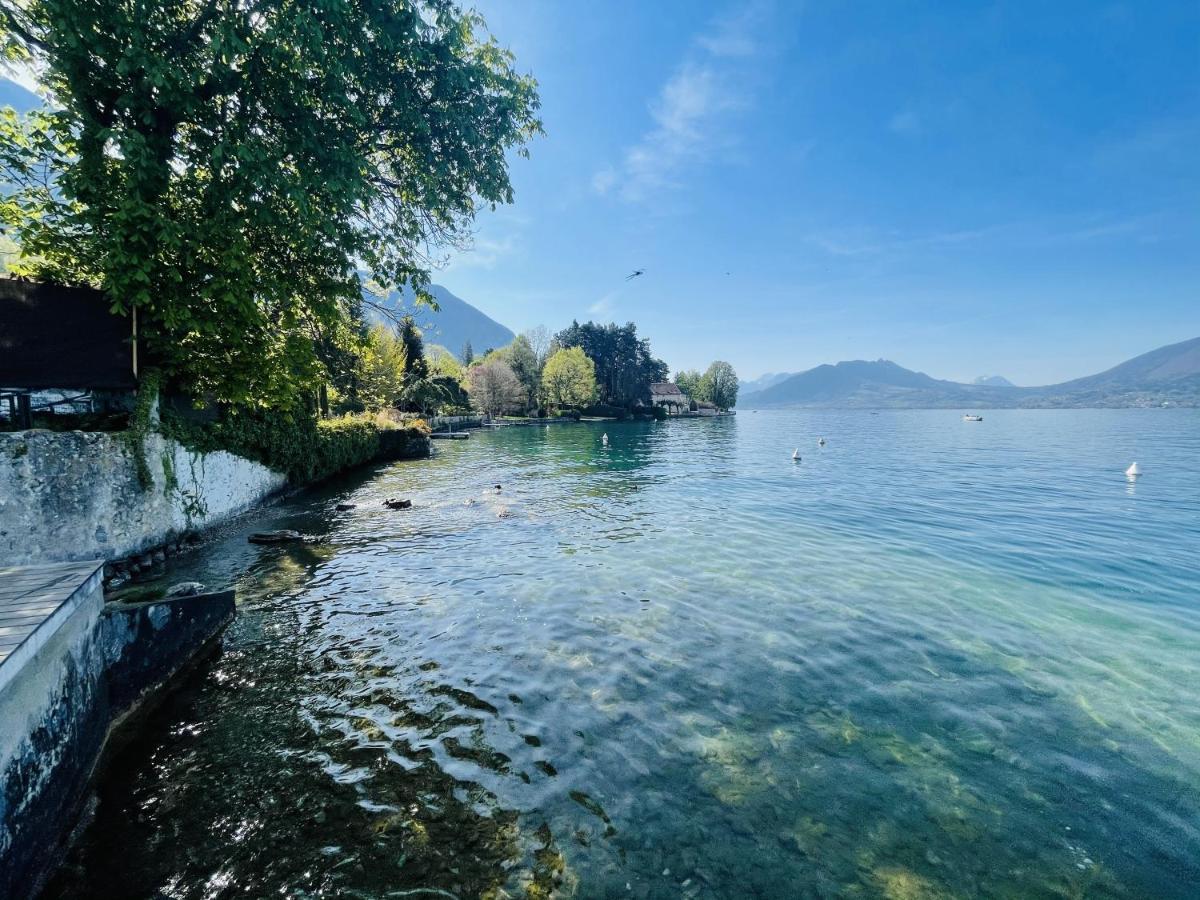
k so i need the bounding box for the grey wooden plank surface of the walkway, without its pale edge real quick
[0,559,104,666]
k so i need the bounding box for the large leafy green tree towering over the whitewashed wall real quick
[0,0,540,404]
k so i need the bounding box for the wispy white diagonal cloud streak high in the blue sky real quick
[592,5,761,202]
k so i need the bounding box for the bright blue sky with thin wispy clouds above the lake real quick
[434,0,1200,384]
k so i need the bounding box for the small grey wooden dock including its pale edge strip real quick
[0,559,104,689]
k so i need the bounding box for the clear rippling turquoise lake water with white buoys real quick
[53,410,1200,898]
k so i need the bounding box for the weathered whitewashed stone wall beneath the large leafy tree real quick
[0,431,287,565]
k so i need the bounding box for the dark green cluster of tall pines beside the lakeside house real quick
[554,322,670,407]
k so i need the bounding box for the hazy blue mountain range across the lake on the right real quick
[739,337,1200,408]
